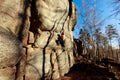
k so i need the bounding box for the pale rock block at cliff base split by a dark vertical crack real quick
[26,49,51,80]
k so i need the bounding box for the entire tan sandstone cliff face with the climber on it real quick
[0,0,76,80]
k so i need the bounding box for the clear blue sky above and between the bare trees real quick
[73,0,120,46]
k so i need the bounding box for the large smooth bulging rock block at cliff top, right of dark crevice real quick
[36,0,69,31]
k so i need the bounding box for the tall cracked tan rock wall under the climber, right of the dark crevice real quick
[25,0,76,80]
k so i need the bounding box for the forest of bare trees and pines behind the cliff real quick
[74,0,120,62]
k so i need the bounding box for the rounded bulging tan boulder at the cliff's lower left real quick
[0,27,22,80]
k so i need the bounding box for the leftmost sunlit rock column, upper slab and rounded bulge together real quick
[0,0,23,80]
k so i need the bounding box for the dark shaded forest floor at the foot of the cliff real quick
[62,56,120,80]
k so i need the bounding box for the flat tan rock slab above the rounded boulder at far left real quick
[0,0,23,34]
